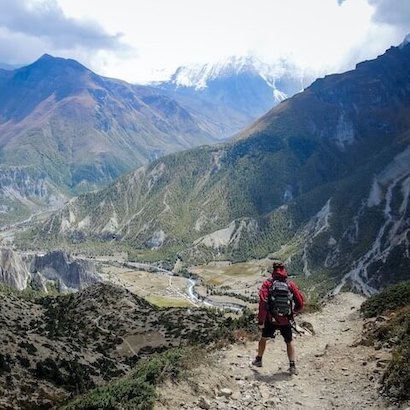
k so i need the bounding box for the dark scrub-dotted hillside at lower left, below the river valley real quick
[0,283,231,410]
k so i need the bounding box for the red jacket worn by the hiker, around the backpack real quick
[258,268,305,326]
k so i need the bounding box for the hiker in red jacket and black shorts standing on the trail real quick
[252,261,304,374]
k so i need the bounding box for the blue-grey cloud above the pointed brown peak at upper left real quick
[0,0,130,63]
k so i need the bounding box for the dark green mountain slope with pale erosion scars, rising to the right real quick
[23,40,410,294]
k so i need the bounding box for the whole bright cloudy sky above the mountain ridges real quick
[0,0,410,84]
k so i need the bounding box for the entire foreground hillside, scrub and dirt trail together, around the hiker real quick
[0,268,410,410]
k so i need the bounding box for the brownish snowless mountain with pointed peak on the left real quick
[0,55,240,222]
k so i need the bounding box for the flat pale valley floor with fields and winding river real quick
[90,257,262,312]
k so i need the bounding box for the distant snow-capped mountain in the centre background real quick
[152,56,313,122]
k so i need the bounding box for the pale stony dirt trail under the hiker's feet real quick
[155,293,395,410]
